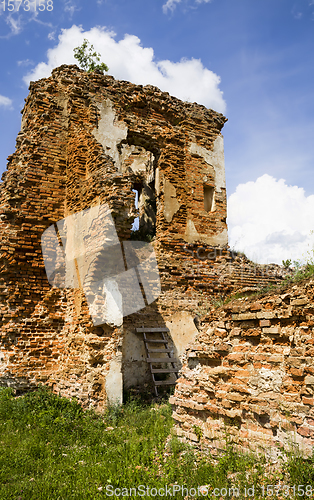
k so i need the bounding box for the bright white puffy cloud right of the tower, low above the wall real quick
[228,174,314,264]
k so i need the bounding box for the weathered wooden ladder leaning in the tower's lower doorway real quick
[136,326,179,396]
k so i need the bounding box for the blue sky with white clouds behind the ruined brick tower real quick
[0,0,314,263]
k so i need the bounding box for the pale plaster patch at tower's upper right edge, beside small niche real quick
[189,135,226,192]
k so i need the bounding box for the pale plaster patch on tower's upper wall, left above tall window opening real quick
[93,99,128,170]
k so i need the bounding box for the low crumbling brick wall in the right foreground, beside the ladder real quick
[170,279,314,453]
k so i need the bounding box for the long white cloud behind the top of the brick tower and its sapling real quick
[24,25,226,113]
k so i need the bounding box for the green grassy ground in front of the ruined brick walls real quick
[0,388,314,500]
